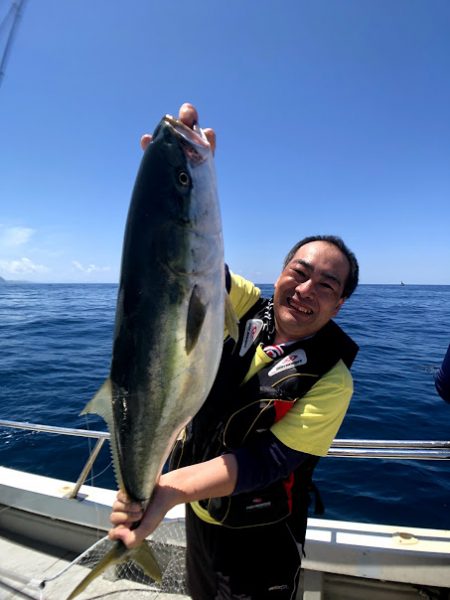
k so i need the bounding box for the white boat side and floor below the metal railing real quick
[0,467,450,600]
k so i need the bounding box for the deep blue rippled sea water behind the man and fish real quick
[0,283,450,529]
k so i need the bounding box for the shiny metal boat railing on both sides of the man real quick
[0,419,450,498]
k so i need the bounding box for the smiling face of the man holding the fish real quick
[274,241,350,343]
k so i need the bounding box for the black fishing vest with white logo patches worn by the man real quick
[169,299,358,543]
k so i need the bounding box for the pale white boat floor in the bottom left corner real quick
[0,532,189,600]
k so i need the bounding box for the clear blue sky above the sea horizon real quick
[0,0,450,284]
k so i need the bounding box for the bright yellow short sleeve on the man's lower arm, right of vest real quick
[271,360,353,456]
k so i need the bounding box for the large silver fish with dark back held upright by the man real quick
[69,115,236,599]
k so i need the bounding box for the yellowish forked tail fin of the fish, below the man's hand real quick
[67,541,162,600]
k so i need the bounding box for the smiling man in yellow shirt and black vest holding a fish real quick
[110,105,358,600]
